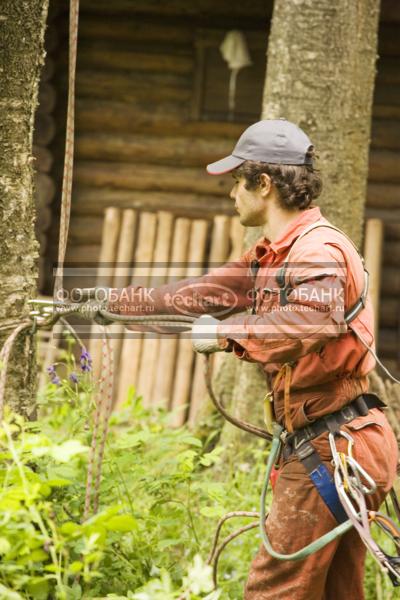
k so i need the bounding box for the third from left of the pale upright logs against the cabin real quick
[116,212,157,407]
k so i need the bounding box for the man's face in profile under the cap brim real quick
[229,171,267,227]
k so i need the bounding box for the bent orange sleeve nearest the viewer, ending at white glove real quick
[218,241,347,364]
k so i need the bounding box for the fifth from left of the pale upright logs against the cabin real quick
[152,218,191,408]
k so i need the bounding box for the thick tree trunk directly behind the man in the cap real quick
[222,0,379,447]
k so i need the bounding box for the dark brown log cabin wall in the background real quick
[48,0,400,373]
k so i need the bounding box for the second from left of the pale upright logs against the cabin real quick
[110,208,138,378]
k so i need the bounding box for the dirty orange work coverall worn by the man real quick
[110,207,397,600]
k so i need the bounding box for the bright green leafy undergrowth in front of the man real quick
[0,342,399,600]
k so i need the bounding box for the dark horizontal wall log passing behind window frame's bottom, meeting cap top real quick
[76,98,250,138]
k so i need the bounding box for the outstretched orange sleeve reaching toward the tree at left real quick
[108,251,253,330]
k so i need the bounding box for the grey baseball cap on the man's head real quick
[207,119,312,175]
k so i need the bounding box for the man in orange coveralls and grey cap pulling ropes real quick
[108,119,397,600]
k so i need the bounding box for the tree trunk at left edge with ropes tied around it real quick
[0,0,48,416]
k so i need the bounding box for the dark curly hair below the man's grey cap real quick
[235,146,322,210]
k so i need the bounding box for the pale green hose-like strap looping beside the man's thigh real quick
[260,424,353,560]
